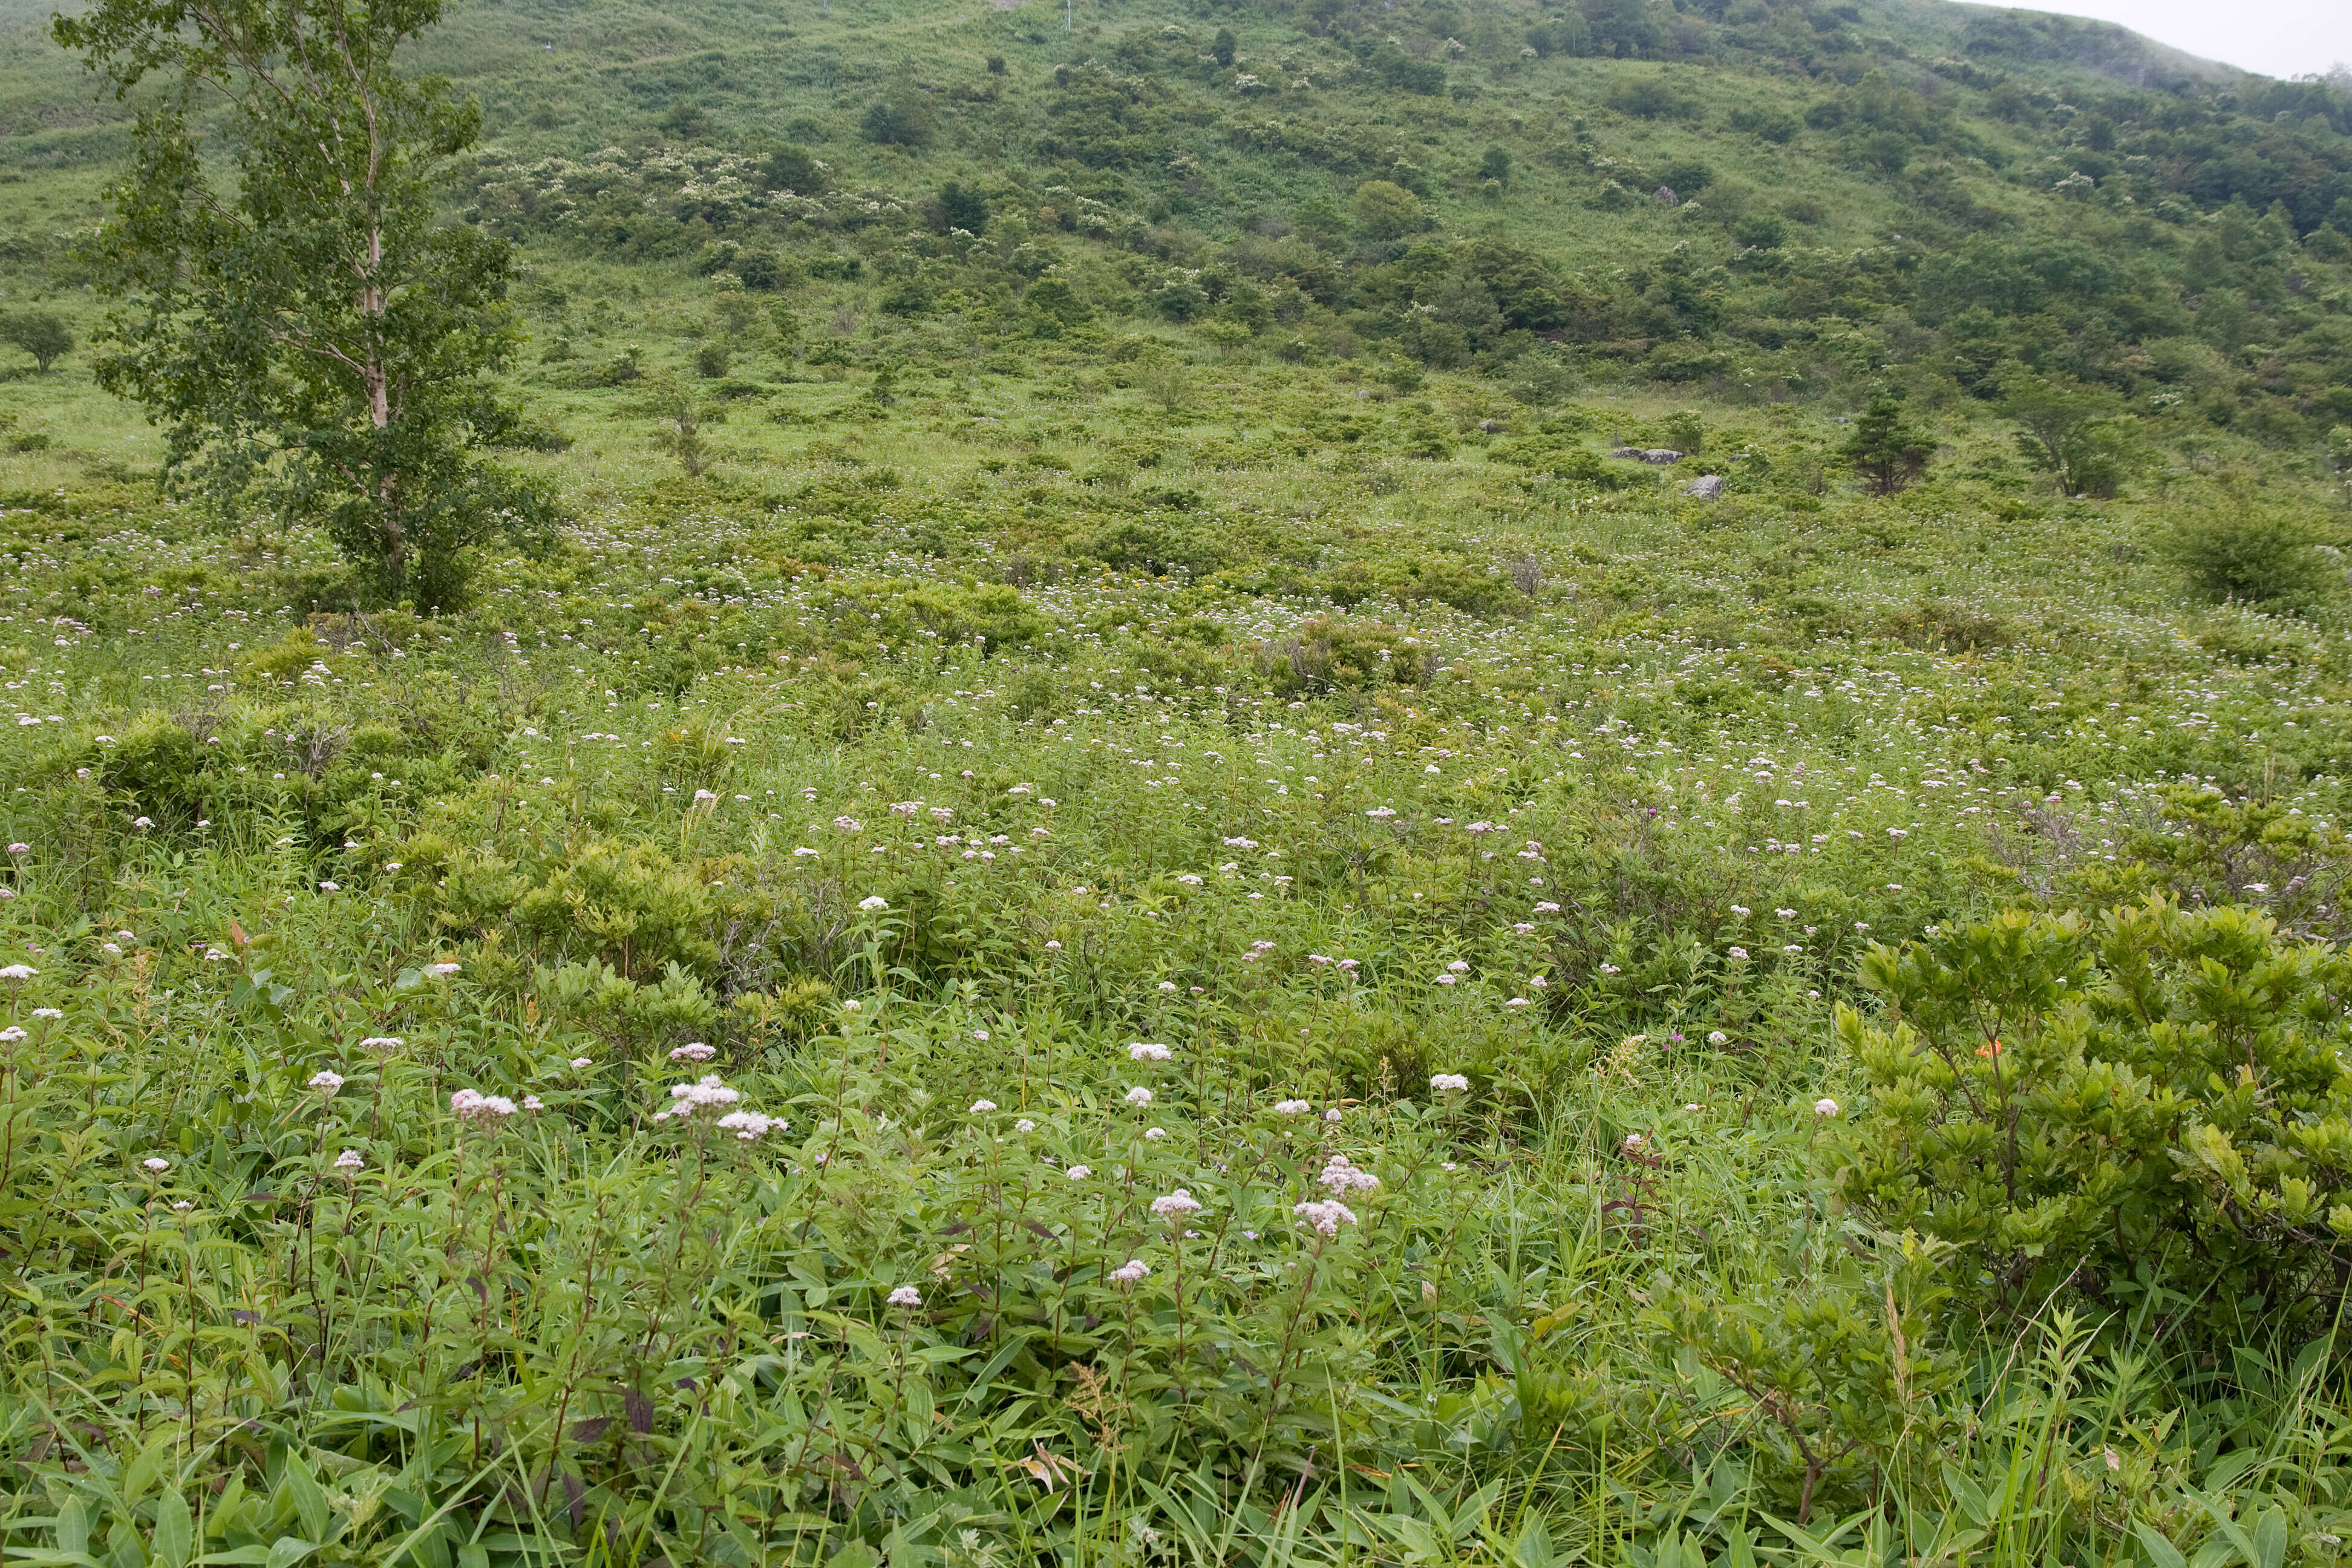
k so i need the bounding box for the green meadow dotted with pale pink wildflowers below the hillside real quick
[0,430,2352,1563]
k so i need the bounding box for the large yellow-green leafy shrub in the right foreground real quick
[1837,900,2352,1333]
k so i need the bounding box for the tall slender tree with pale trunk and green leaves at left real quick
[54,0,538,607]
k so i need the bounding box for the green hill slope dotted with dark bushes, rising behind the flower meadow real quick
[0,0,2352,479]
